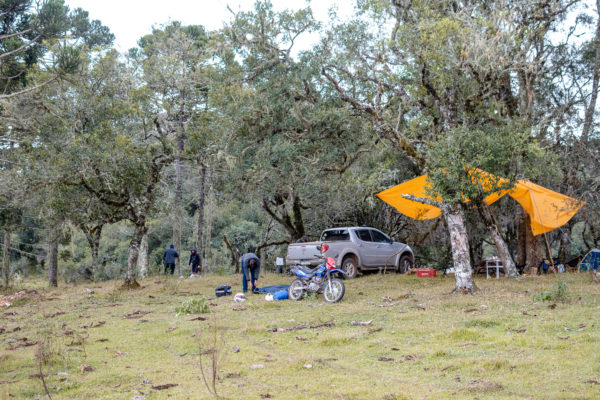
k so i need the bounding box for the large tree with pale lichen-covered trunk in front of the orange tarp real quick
[322,1,571,291]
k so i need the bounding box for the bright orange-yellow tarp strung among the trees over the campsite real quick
[376,170,583,235]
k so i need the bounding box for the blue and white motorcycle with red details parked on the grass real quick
[288,245,346,303]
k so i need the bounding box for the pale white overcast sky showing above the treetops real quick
[66,0,355,51]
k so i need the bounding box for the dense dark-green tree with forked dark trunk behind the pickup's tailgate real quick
[215,2,371,244]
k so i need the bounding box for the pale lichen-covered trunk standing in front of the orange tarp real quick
[442,204,477,293]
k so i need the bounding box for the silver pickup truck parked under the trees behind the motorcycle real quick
[286,226,415,278]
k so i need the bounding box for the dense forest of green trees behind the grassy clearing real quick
[0,0,600,286]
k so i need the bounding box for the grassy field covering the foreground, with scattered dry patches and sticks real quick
[0,274,600,400]
